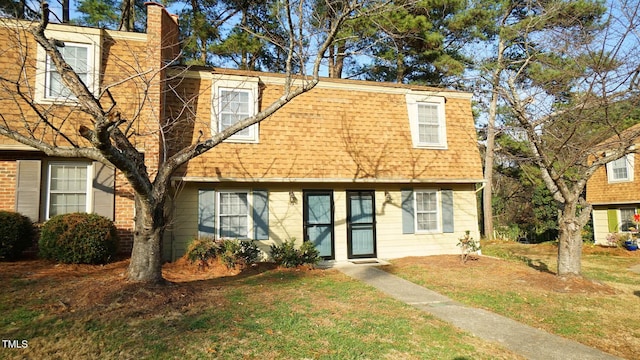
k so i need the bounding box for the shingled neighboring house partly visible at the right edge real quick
[587,125,640,244]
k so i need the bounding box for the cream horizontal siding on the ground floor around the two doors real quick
[164,183,480,261]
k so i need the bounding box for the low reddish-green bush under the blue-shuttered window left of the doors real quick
[186,238,260,269]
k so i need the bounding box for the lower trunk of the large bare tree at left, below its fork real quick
[128,195,164,283]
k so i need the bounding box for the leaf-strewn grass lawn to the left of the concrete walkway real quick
[0,264,518,360]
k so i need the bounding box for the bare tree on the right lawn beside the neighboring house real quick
[494,1,640,276]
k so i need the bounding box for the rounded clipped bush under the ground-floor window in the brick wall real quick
[39,213,118,264]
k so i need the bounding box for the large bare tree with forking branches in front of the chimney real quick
[0,0,388,282]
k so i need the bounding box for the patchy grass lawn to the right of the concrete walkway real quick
[388,243,640,358]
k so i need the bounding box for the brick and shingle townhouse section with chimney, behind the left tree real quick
[0,3,179,252]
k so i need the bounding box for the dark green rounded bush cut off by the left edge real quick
[0,211,34,260]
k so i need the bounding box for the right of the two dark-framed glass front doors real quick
[347,191,377,259]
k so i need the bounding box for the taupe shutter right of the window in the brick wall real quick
[93,161,116,220]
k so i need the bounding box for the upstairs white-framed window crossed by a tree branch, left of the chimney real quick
[35,28,102,103]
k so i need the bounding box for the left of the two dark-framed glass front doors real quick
[303,190,335,260]
